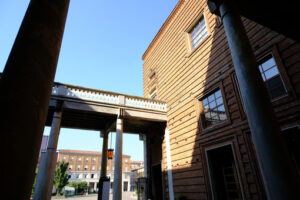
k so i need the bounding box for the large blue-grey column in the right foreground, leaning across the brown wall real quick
[208,0,300,200]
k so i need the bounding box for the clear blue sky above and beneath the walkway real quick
[0,0,177,160]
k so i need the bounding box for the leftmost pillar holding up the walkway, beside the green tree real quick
[33,111,62,200]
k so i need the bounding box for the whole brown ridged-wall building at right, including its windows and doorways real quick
[142,0,300,200]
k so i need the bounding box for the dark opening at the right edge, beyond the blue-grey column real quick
[282,126,300,178]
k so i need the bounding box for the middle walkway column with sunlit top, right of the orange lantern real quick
[113,117,123,200]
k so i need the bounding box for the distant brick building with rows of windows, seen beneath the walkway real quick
[57,149,131,191]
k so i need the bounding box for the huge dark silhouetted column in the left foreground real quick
[0,0,69,199]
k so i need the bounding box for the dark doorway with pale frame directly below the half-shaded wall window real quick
[207,144,243,200]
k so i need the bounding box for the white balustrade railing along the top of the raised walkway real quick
[52,83,167,111]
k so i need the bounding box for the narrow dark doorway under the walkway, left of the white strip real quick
[152,164,163,200]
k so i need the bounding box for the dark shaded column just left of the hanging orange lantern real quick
[98,131,109,200]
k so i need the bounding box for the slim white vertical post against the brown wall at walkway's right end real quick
[165,128,174,200]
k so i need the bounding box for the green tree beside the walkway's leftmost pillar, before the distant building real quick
[54,161,69,194]
